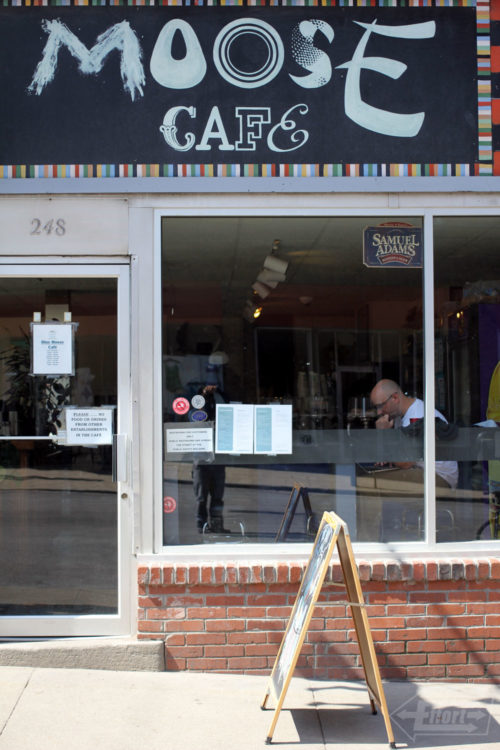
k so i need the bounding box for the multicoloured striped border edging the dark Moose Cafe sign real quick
[0,0,492,179]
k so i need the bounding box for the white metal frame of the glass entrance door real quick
[0,257,133,638]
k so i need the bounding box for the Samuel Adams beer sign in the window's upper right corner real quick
[363,224,423,268]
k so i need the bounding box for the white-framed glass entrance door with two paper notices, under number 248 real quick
[0,264,131,637]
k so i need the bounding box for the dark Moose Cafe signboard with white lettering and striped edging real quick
[0,3,484,177]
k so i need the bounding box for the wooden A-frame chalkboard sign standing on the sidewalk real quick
[261,513,396,748]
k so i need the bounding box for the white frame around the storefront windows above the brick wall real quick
[151,204,500,562]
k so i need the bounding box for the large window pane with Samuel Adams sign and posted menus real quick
[162,216,438,545]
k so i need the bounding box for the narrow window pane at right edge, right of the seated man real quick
[434,216,500,541]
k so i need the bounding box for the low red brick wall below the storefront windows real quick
[138,558,500,682]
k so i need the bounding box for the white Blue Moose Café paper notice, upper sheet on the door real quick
[32,323,74,375]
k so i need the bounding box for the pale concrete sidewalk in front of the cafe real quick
[0,667,500,750]
